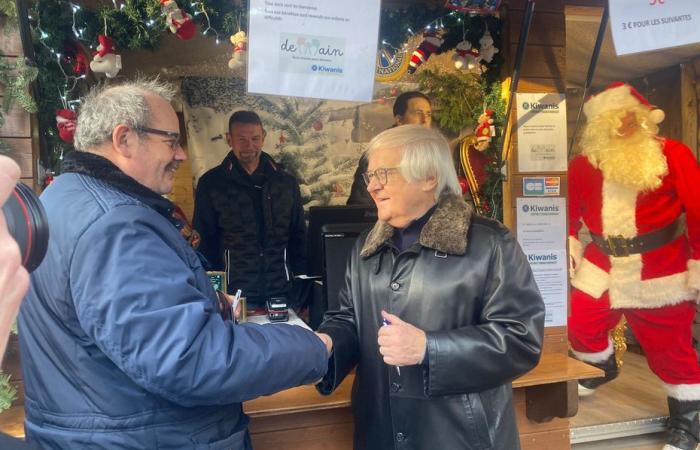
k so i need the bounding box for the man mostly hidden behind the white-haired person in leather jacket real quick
[347,91,433,206]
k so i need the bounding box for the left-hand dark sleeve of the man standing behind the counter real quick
[192,172,224,270]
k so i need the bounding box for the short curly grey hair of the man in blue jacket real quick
[74,78,175,151]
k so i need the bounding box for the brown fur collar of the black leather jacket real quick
[360,194,474,258]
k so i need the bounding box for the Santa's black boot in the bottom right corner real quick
[663,397,700,450]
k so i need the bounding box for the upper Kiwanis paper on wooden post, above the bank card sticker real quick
[516,93,567,172]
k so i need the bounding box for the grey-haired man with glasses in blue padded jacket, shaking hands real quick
[19,80,328,450]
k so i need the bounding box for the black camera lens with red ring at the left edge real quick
[2,183,49,272]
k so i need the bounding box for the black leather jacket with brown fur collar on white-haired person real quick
[317,195,544,450]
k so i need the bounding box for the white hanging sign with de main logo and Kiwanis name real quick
[248,0,381,102]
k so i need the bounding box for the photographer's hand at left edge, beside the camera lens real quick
[0,156,29,360]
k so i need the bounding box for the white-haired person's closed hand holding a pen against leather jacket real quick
[377,311,427,366]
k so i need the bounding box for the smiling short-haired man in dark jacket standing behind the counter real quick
[194,111,306,307]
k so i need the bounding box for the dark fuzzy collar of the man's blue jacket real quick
[63,151,179,230]
